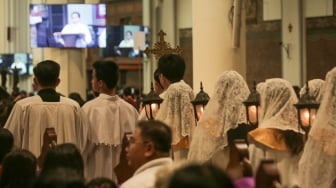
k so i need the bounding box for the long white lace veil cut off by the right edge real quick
[299,67,336,188]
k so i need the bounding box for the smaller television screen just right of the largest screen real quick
[103,25,150,58]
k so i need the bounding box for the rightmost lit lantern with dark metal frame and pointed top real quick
[295,82,320,136]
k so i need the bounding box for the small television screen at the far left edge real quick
[0,53,33,75]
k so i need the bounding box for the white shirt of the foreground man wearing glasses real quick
[120,157,173,188]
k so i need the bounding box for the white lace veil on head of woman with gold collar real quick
[258,78,299,132]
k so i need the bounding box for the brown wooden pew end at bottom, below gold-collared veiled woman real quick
[256,159,281,188]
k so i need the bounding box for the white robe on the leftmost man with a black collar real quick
[5,96,88,156]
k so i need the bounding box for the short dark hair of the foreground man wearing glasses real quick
[137,120,172,153]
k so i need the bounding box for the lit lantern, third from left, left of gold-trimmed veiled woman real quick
[243,82,260,126]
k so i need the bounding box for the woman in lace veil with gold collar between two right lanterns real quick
[248,78,303,187]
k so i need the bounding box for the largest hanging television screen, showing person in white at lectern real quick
[29,4,106,48]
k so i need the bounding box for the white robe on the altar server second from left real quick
[82,94,138,182]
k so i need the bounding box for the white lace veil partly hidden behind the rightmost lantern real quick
[300,79,325,102]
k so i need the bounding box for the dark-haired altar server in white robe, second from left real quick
[82,60,138,182]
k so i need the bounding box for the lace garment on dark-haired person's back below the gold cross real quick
[156,80,195,145]
